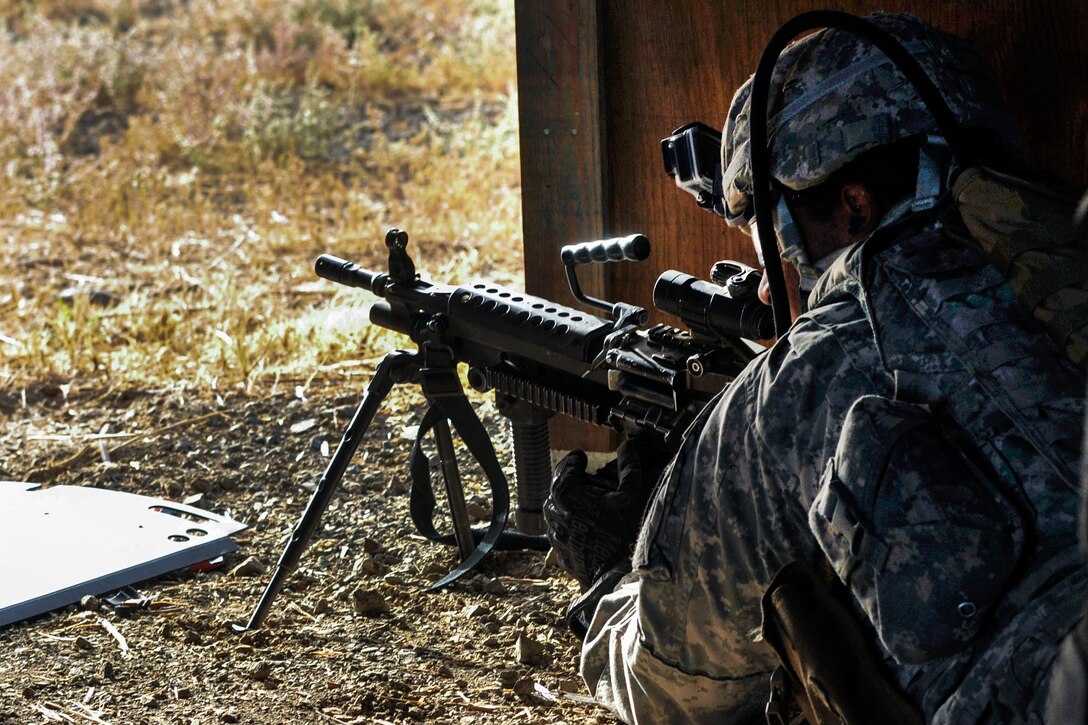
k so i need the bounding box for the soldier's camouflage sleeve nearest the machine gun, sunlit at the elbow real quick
[581,296,887,723]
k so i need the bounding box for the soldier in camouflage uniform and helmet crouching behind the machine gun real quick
[545,14,1088,725]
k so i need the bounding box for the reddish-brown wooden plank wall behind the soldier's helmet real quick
[516,0,1088,446]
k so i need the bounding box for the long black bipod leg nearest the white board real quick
[234,351,419,631]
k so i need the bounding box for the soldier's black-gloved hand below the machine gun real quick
[544,440,665,592]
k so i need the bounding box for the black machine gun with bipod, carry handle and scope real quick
[236,230,774,630]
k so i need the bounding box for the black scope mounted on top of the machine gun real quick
[654,269,775,340]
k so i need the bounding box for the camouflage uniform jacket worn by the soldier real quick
[581,217,1088,725]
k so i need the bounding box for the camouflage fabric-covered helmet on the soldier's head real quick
[721,13,1023,231]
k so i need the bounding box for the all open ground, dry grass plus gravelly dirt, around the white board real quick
[0,0,608,724]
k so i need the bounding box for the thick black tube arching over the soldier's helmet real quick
[749,10,968,337]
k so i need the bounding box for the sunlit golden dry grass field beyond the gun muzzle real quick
[0,0,521,392]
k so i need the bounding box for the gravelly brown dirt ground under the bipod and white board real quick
[0,370,613,723]
